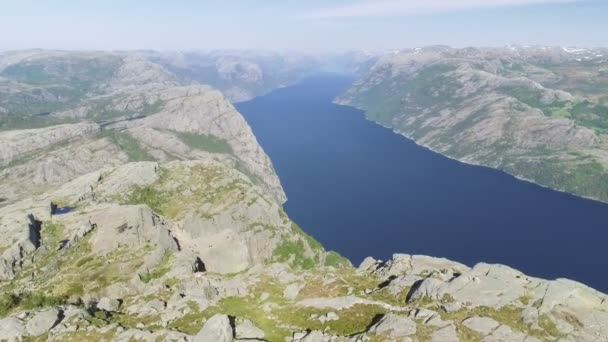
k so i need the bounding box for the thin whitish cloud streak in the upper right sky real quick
[302,0,580,19]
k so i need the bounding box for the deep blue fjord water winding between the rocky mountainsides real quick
[237,75,608,292]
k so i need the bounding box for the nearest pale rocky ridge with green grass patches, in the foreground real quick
[0,158,608,341]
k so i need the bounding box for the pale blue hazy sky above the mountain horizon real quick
[0,0,608,52]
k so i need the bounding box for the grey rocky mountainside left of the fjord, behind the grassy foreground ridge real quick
[0,51,285,205]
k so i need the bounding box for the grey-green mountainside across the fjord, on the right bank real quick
[337,47,608,201]
